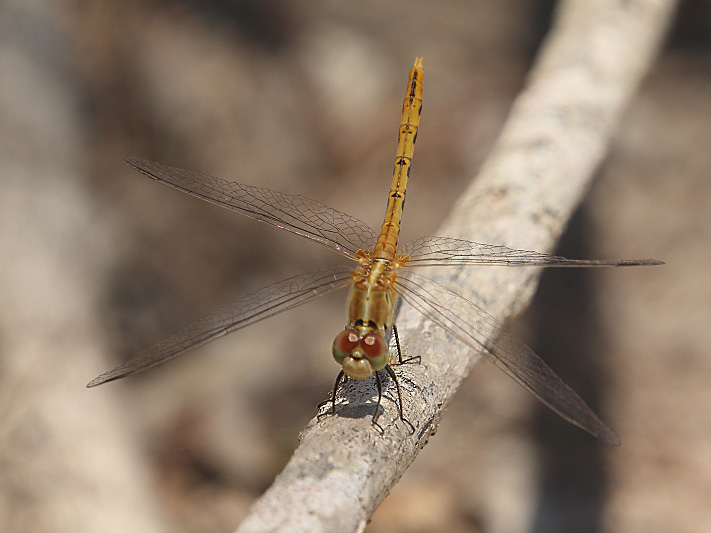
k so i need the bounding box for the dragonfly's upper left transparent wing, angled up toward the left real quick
[124,157,378,259]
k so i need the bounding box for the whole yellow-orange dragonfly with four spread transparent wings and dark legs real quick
[87,57,663,445]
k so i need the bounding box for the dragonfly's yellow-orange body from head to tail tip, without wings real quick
[333,57,424,379]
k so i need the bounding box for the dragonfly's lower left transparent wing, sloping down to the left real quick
[87,266,351,387]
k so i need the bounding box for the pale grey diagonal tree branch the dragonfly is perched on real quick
[239,0,675,532]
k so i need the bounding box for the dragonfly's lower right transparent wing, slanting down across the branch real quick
[396,272,619,445]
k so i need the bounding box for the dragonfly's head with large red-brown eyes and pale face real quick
[331,327,390,380]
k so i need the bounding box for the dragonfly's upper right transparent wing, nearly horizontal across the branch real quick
[402,237,663,267]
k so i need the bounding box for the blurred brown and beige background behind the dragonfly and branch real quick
[0,0,711,533]
